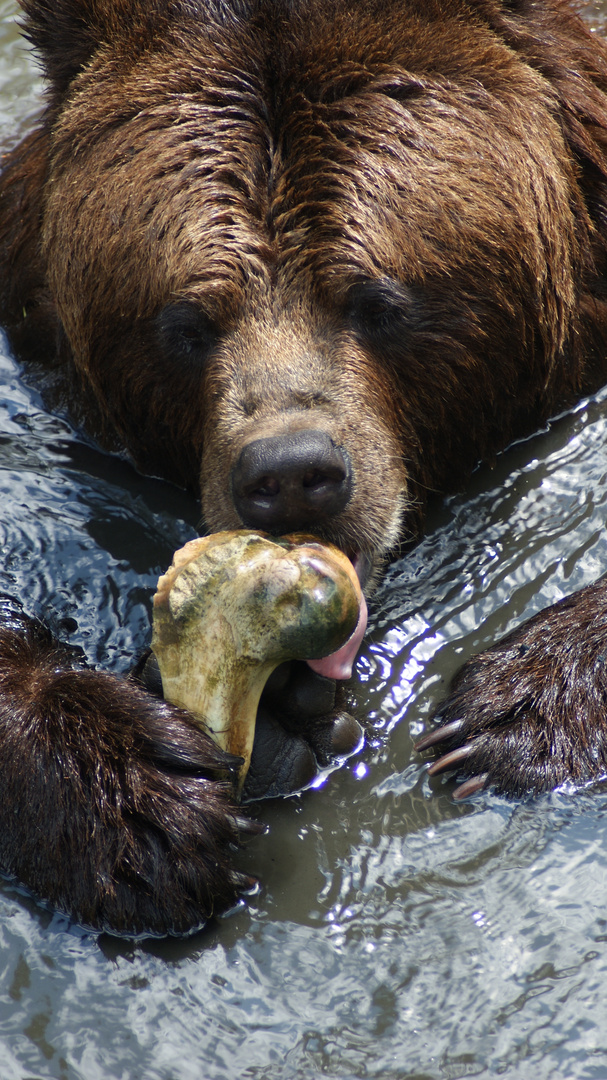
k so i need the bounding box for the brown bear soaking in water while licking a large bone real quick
[0,0,607,932]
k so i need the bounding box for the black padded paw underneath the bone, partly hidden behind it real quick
[135,653,363,801]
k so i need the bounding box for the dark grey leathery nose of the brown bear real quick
[232,430,352,535]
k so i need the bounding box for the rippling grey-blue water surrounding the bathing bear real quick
[0,0,607,1080]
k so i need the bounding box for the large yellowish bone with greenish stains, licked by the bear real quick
[152,530,361,786]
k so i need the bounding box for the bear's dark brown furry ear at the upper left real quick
[19,0,173,92]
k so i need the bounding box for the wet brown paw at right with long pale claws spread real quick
[416,582,607,798]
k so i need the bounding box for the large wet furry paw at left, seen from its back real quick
[0,606,259,934]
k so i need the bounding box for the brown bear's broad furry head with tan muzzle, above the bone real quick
[3,0,605,591]
